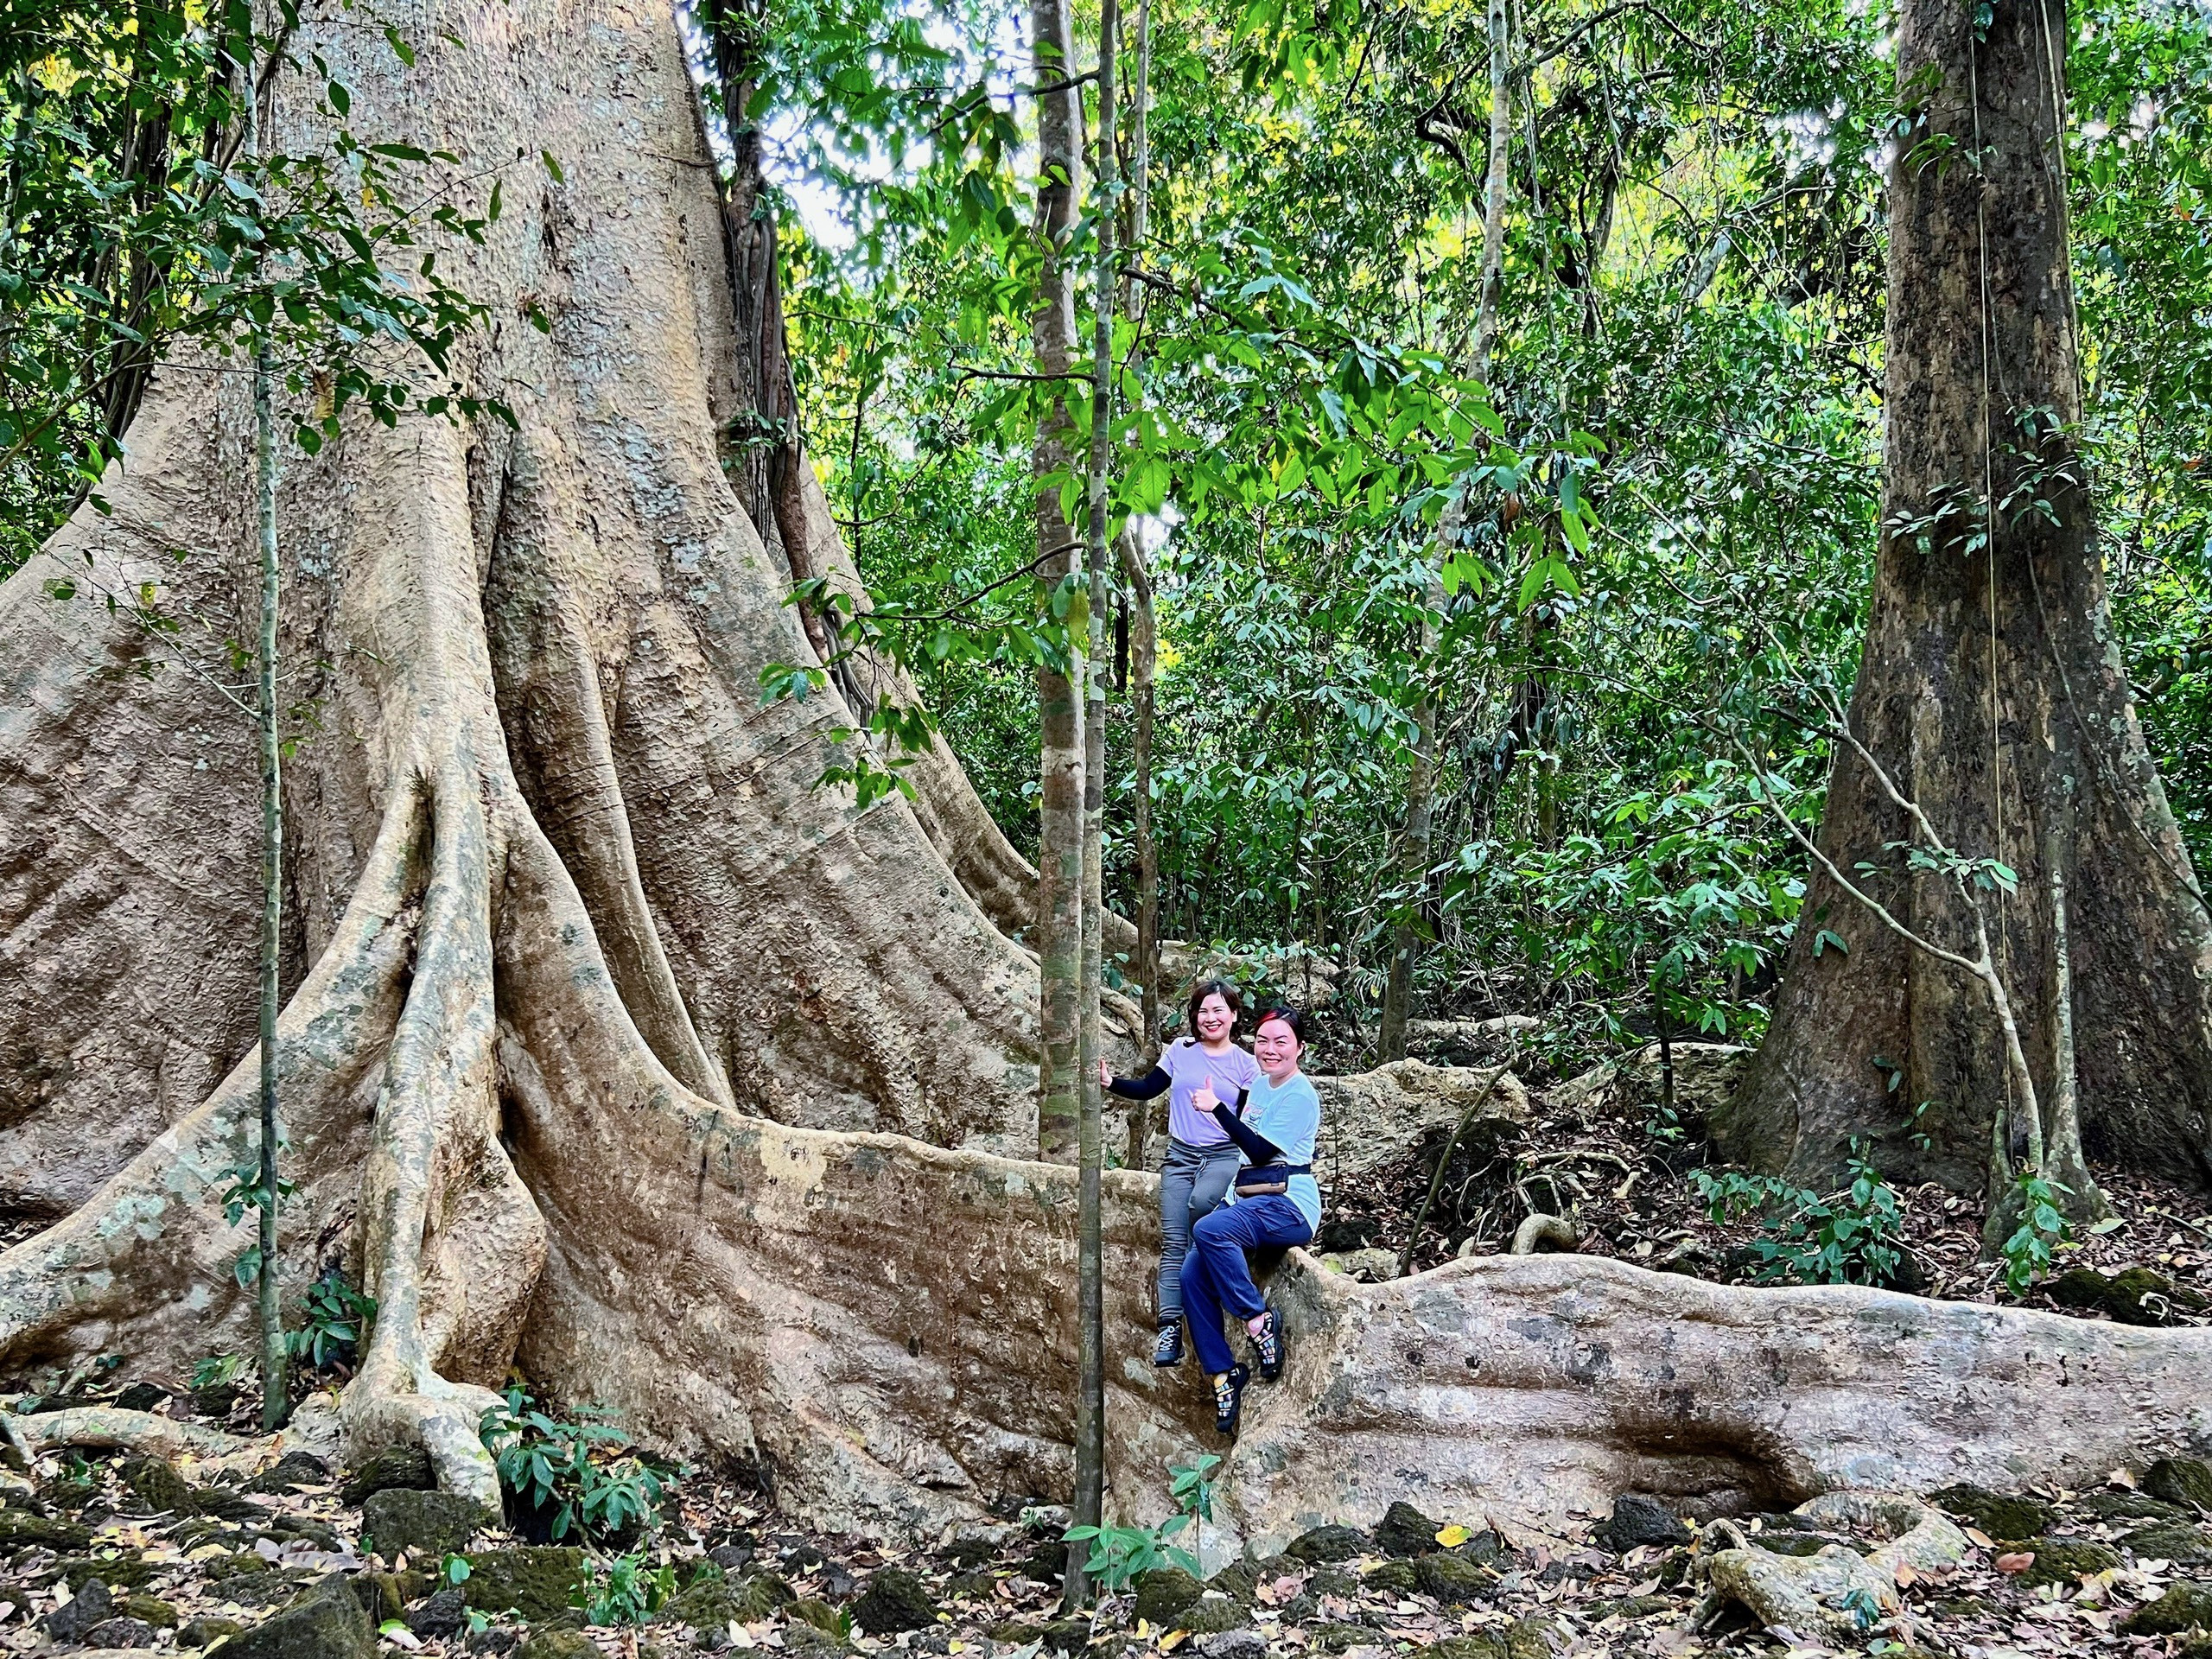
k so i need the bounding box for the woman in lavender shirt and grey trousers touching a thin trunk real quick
[1099,980,1259,1365]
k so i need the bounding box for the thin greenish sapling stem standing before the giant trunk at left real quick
[244,35,289,1429]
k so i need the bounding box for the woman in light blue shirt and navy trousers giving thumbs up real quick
[1184,1008,1320,1435]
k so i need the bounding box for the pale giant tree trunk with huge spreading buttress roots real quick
[0,0,2212,1544]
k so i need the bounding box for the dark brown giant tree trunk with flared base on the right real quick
[1717,0,2212,1190]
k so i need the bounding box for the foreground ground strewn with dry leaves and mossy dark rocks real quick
[0,1458,2212,1659]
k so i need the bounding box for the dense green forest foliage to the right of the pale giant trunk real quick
[739,0,2212,1092]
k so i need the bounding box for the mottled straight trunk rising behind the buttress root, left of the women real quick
[1031,0,1084,1164]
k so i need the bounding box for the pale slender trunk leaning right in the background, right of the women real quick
[1376,0,1513,1064]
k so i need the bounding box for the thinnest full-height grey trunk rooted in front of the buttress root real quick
[1062,0,1122,1608]
